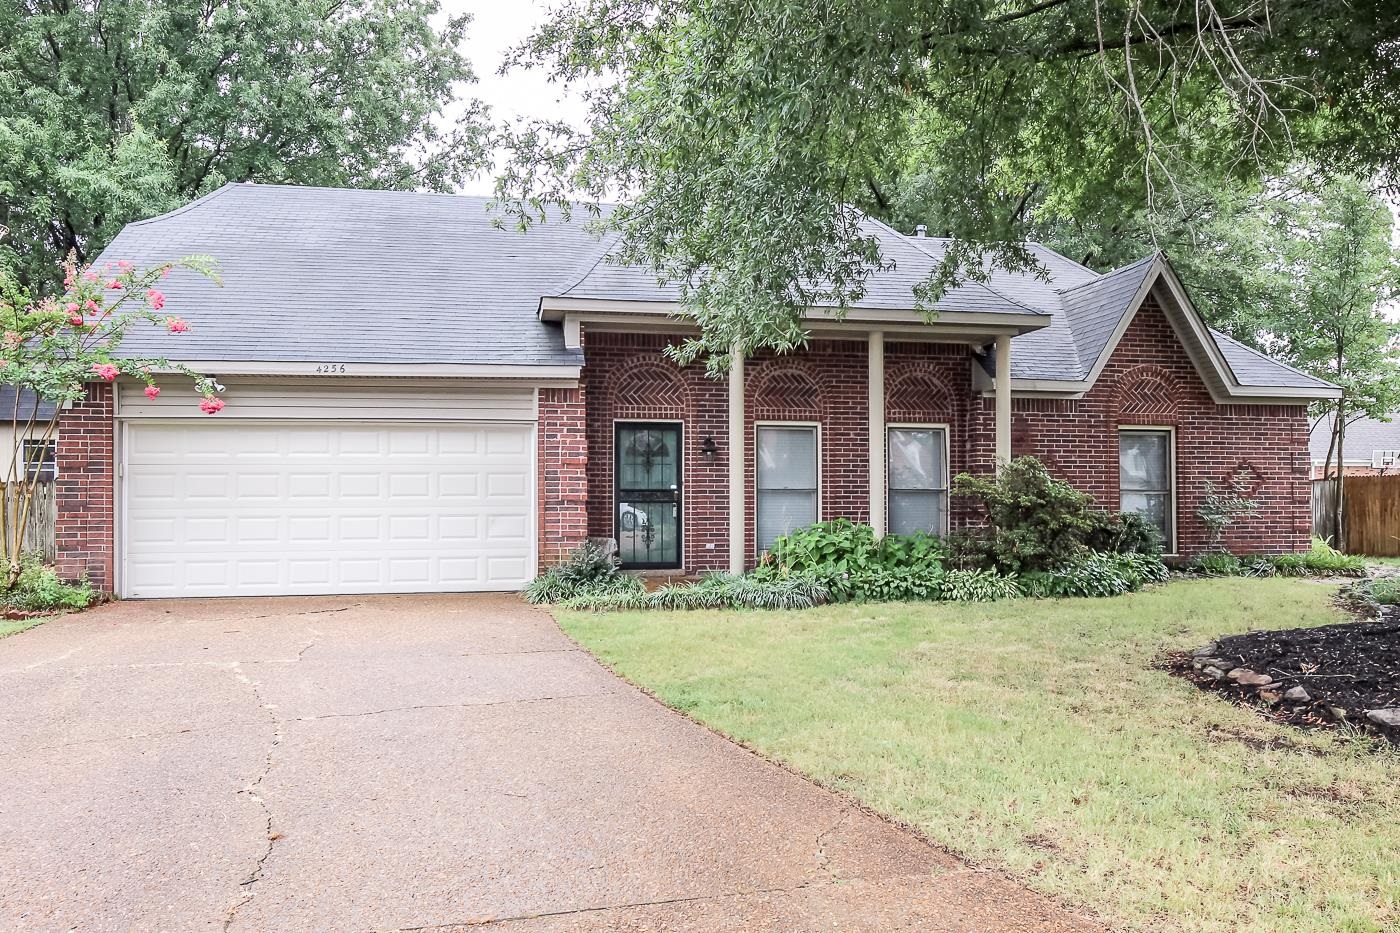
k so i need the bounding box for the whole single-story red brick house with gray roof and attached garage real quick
[56,185,1336,597]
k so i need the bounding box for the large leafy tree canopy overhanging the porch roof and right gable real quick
[500,0,1400,366]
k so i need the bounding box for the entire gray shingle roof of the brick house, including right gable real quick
[99,185,1336,398]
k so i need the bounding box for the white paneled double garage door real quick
[122,422,535,597]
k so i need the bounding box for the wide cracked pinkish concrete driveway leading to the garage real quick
[0,597,1081,932]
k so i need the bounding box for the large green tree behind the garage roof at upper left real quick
[0,0,484,286]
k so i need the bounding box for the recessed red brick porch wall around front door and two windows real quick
[584,332,974,572]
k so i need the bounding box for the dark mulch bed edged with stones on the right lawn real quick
[1168,607,1400,742]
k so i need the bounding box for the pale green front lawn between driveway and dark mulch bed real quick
[559,579,1400,930]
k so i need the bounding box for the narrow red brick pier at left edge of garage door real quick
[55,382,116,593]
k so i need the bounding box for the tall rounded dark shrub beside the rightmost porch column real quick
[953,457,1099,573]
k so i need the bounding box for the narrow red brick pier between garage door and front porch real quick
[535,388,588,569]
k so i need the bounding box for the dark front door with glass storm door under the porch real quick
[613,422,680,569]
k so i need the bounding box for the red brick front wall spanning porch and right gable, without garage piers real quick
[571,304,1310,572]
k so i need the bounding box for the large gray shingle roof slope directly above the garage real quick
[101,185,598,366]
